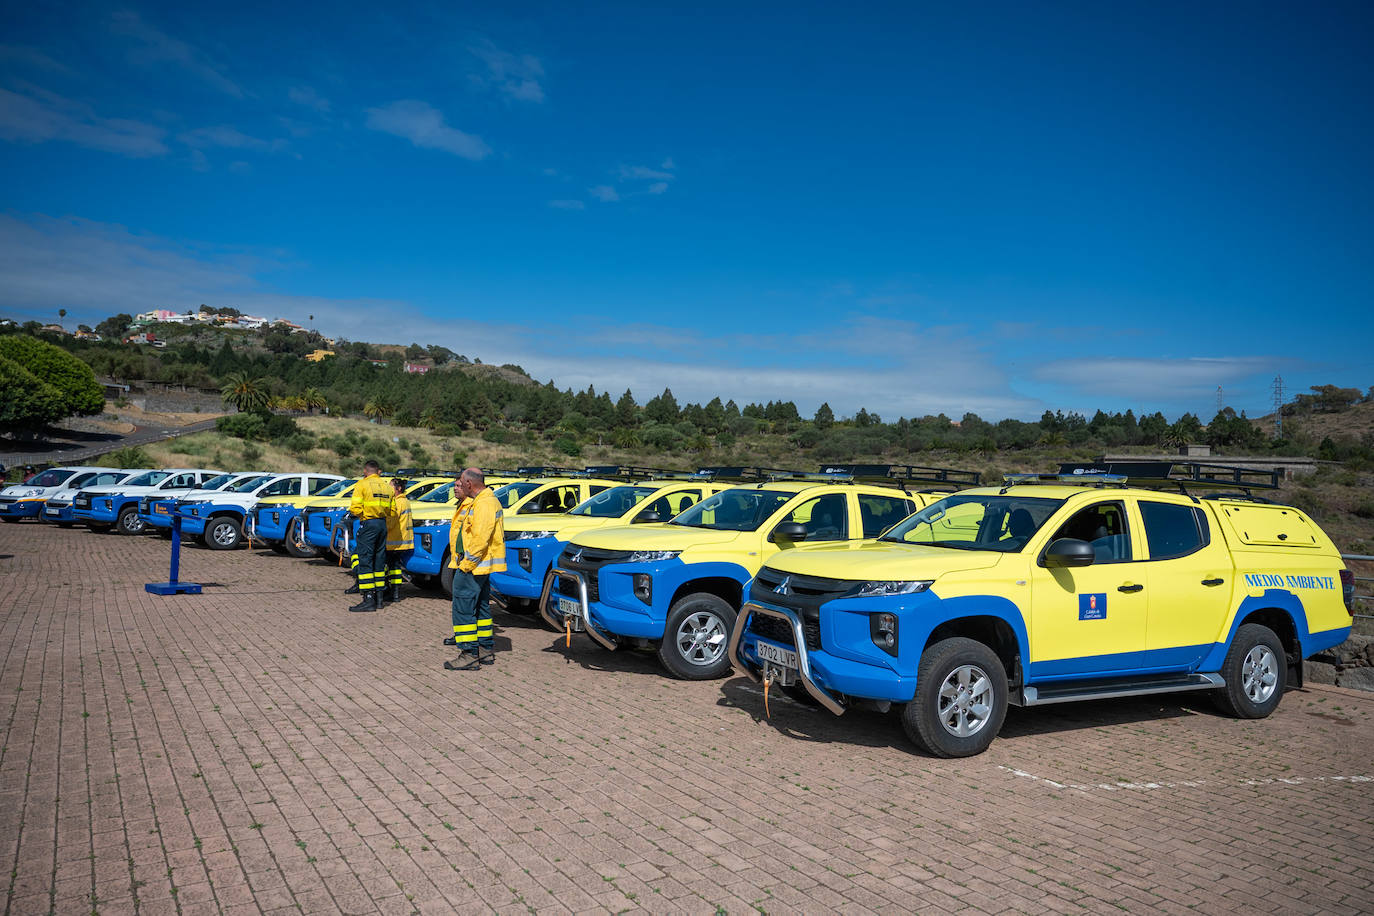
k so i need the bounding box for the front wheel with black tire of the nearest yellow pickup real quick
[901,636,1007,757]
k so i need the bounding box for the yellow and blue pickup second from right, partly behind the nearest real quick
[535,464,978,680]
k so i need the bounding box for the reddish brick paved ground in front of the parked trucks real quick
[0,523,1374,915]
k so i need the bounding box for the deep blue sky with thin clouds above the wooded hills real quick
[0,3,1374,420]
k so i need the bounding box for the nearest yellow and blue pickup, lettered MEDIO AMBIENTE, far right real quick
[730,461,1355,757]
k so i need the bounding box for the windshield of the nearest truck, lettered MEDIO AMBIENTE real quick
[878,493,1063,553]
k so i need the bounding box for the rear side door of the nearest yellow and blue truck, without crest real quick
[1138,497,1235,670]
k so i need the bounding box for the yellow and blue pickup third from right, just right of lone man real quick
[492,466,725,611]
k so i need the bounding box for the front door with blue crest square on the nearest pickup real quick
[1029,499,1149,680]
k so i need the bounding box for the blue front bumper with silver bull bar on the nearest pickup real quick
[727,602,916,715]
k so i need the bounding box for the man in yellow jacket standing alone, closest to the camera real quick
[444,467,506,672]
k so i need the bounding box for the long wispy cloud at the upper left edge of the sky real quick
[0,88,168,158]
